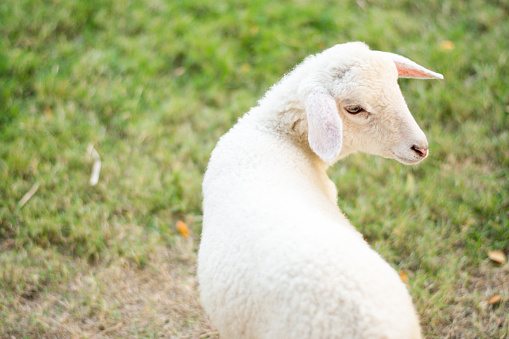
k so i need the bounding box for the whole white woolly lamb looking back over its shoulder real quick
[198,42,443,339]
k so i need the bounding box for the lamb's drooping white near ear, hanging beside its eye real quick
[305,91,343,163]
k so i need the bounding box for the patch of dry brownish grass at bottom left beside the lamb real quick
[2,239,218,338]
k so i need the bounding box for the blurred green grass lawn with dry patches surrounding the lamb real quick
[0,0,509,338]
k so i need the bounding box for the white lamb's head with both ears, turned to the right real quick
[299,42,443,165]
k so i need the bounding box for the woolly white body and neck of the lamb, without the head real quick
[198,44,438,339]
